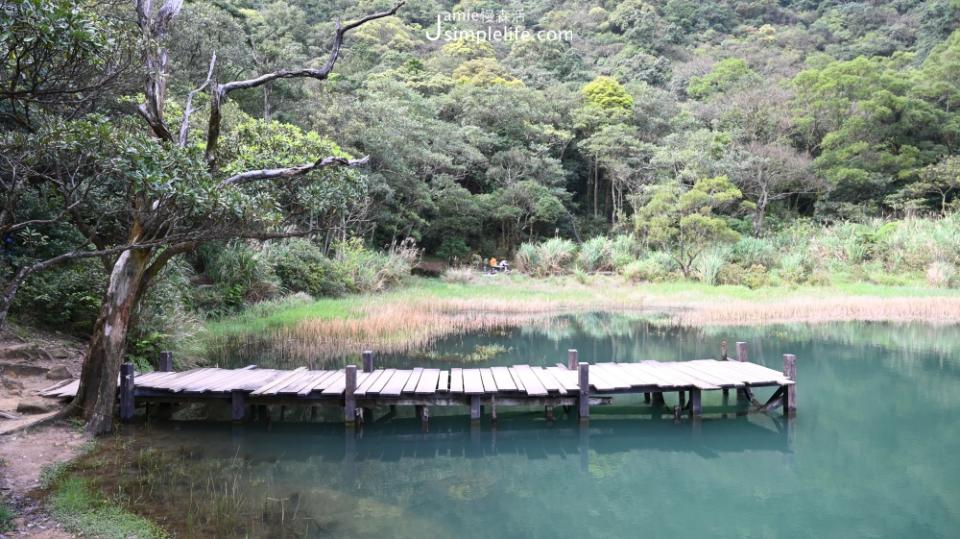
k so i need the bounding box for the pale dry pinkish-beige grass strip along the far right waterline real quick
[674,297,960,326]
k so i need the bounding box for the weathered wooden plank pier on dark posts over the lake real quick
[41,343,796,426]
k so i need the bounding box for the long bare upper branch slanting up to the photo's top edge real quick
[205,2,405,169]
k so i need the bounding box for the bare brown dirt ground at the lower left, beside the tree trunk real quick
[0,327,90,539]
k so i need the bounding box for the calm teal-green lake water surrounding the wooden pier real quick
[91,315,960,538]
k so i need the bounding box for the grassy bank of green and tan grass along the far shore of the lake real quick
[189,274,960,365]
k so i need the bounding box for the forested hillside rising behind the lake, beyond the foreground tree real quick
[169,0,960,258]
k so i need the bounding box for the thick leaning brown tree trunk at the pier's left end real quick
[74,249,151,434]
